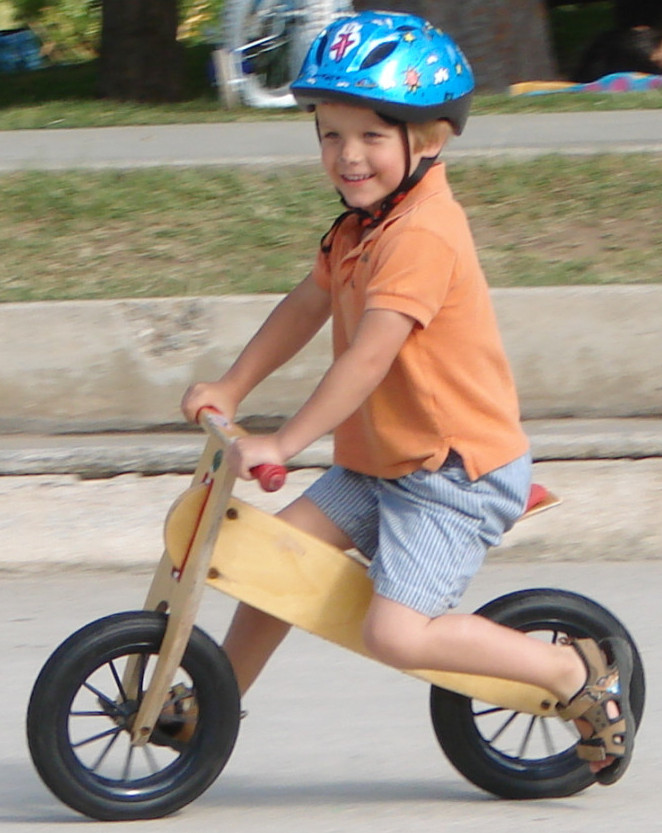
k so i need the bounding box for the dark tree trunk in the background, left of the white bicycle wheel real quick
[99,0,183,103]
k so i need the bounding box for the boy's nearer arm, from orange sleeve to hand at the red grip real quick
[231,310,414,478]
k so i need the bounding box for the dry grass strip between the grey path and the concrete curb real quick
[0,155,662,302]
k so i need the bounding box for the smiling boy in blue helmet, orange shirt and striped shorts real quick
[182,12,634,783]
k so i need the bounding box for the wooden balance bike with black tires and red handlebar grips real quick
[27,409,645,820]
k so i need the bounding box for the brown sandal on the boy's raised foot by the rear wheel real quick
[557,637,635,784]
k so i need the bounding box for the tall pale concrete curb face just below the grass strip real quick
[0,285,662,434]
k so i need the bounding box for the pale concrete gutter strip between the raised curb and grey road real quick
[0,457,662,573]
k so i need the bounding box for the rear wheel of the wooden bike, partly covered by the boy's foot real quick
[430,589,645,799]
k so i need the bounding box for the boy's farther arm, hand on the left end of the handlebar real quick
[182,275,331,422]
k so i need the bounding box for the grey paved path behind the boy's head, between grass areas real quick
[0,110,662,171]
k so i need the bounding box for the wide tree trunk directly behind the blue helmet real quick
[354,0,557,92]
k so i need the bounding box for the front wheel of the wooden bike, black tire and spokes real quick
[27,611,239,821]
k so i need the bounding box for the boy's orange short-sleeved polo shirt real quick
[313,164,528,479]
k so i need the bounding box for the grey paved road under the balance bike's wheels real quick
[0,562,662,833]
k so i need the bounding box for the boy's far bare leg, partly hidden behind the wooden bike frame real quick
[223,497,352,695]
